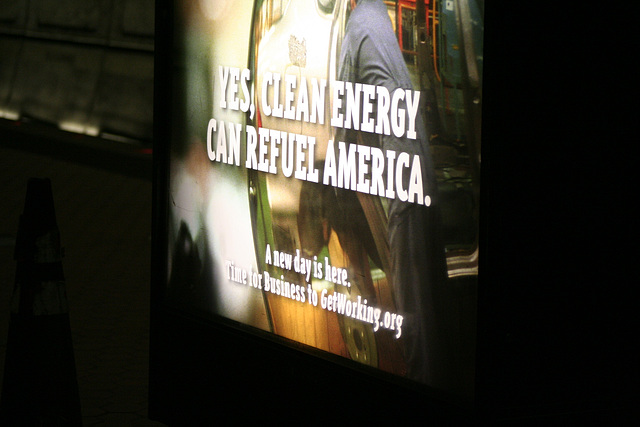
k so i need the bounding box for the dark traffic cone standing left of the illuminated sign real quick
[0,178,82,426]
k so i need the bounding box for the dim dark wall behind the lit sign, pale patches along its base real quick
[0,0,155,141]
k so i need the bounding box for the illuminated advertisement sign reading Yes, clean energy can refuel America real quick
[160,0,484,402]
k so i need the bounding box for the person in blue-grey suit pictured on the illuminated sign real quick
[336,0,449,387]
